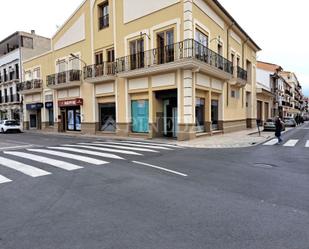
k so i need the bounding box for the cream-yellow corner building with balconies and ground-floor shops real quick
[24,0,260,140]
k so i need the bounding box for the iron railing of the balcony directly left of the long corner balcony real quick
[84,62,116,79]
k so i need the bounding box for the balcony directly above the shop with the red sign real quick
[46,70,82,89]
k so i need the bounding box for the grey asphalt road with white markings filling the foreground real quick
[0,124,309,249]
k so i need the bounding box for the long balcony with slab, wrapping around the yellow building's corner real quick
[116,39,233,80]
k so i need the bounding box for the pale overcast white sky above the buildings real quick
[0,0,309,96]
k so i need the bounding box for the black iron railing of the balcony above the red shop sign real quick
[46,69,82,86]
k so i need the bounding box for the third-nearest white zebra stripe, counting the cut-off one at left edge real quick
[4,151,83,171]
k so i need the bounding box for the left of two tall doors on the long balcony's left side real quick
[130,39,144,70]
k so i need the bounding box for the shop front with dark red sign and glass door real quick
[58,98,83,132]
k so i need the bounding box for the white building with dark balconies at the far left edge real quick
[0,31,51,121]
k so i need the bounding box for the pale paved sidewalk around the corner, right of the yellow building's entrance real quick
[177,128,280,148]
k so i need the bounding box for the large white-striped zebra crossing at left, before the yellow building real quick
[0,141,183,185]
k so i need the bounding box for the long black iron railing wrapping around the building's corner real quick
[116,39,233,74]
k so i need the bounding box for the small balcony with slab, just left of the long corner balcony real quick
[84,62,116,83]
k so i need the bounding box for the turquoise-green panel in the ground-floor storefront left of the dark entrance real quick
[132,100,149,133]
